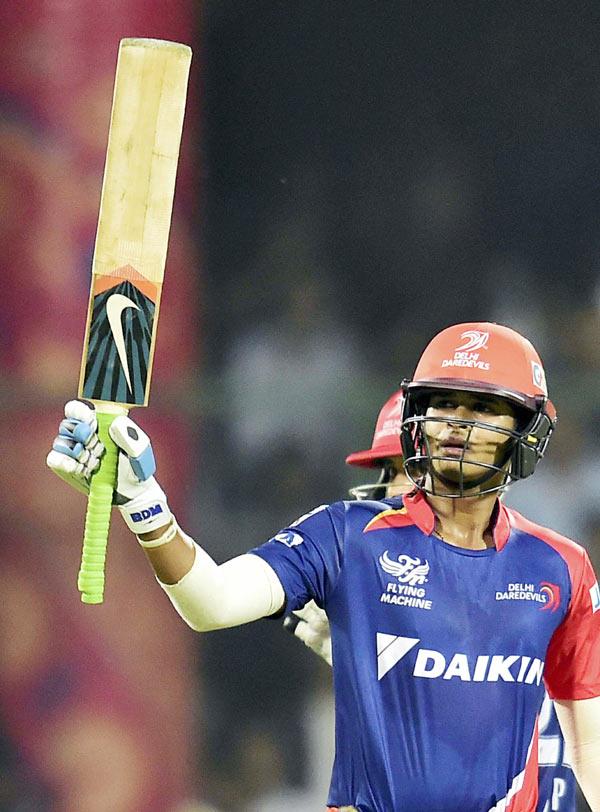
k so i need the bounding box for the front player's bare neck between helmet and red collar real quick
[427,493,498,550]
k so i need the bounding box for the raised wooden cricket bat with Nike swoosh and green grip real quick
[77,39,192,603]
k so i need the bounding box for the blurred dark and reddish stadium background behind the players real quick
[0,0,600,812]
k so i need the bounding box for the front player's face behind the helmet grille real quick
[424,390,517,490]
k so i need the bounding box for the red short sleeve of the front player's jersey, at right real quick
[544,547,600,700]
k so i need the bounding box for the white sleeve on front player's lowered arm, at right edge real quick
[554,696,600,812]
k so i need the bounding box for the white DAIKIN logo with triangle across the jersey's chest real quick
[377,632,544,685]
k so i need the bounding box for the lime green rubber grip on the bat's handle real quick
[77,412,119,603]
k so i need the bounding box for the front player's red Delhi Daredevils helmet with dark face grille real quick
[402,322,556,496]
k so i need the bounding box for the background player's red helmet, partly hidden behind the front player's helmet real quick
[346,391,404,499]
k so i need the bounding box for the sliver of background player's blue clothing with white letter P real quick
[537,695,577,812]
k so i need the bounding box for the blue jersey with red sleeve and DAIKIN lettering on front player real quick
[252,493,600,812]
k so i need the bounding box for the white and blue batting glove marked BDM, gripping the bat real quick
[46,400,175,546]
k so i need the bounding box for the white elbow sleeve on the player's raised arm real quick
[158,540,285,632]
